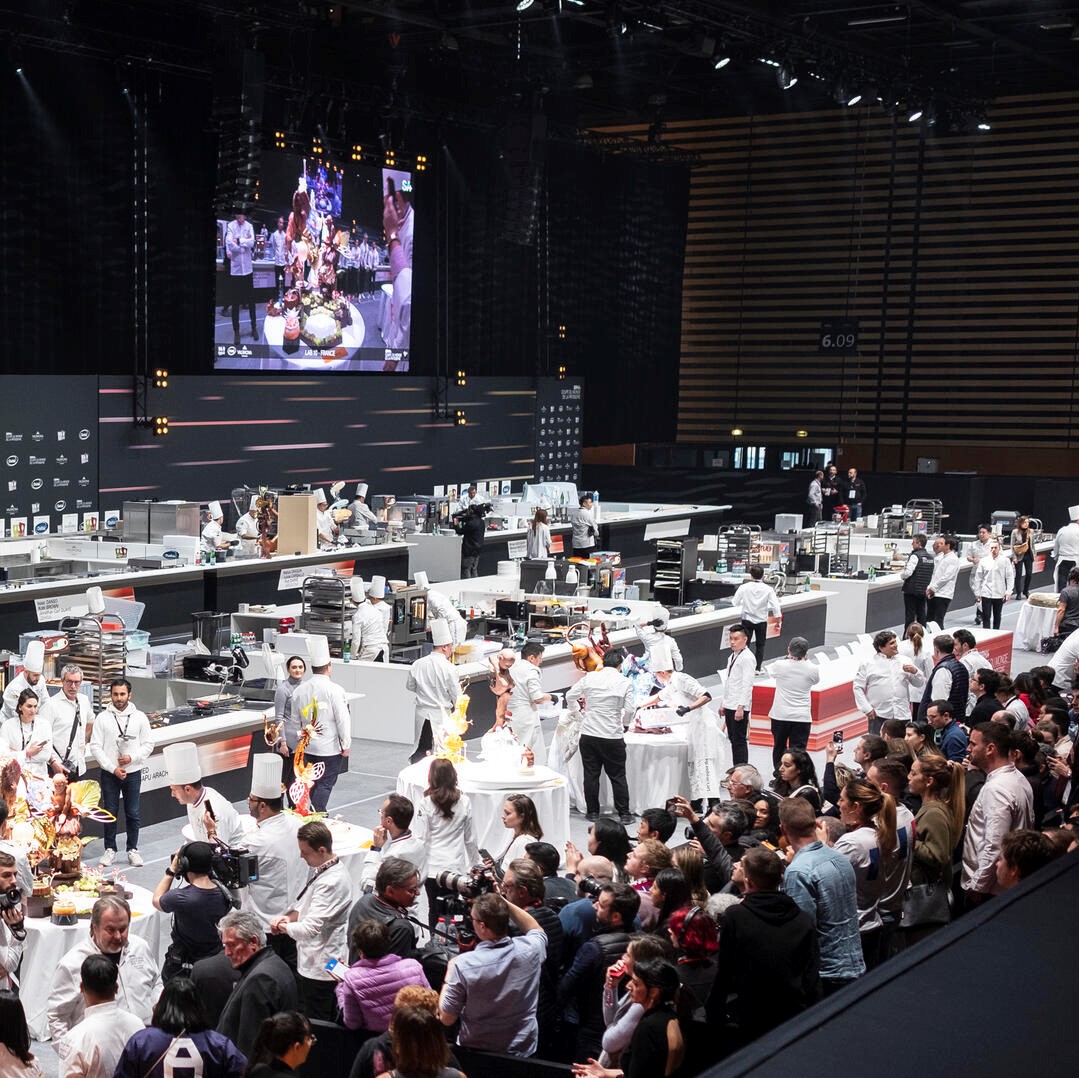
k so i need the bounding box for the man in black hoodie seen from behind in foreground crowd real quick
[707,846,820,1054]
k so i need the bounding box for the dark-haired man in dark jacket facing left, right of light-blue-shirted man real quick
[559,884,641,1060]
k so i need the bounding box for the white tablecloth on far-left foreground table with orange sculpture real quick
[18,884,164,1040]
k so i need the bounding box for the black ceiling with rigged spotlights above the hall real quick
[6,0,1079,139]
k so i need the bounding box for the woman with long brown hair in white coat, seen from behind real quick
[412,758,480,931]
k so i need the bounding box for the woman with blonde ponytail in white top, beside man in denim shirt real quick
[834,778,897,969]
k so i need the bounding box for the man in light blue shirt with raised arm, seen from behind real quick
[438,895,547,1056]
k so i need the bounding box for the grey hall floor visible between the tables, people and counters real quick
[27,602,1044,1078]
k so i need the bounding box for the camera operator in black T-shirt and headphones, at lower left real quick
[153,842,232,984]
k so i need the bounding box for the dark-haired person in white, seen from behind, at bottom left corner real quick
[56,954,145,1078]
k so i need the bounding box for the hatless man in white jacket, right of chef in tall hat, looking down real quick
[270,820,353,1022]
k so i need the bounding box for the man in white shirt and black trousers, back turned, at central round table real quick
[566,649,637,823]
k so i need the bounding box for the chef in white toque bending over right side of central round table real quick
[641,641,733,809]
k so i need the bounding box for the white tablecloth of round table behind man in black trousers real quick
[547,726,689,816]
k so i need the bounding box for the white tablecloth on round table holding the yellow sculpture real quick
[397,759,570,857]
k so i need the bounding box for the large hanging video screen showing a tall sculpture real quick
[214,152,414,373]
